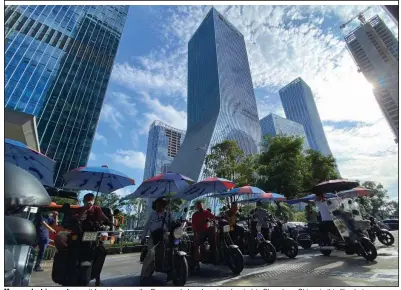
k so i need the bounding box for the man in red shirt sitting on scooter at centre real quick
[192,201,216,263]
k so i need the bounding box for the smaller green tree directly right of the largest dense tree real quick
[303,149,339,189]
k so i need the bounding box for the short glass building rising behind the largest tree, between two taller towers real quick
[260,114,309,151]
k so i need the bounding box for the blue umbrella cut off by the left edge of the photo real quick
[4,139,56,186]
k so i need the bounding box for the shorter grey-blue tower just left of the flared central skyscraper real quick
[143,121,185,218]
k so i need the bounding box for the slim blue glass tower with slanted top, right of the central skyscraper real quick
[279,78,332,156]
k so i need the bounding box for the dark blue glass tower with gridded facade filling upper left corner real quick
[4,5,128,186]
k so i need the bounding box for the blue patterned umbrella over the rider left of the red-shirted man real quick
[123,172,195,200]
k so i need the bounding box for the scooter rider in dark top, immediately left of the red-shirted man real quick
[141,197,169,282]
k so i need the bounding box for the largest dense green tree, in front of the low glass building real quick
[257,136,305,199]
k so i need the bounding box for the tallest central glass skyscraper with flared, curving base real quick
[171,8,261,180]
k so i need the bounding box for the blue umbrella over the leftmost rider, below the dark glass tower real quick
[63,165,135,193]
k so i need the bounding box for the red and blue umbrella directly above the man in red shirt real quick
[175,177,235,200]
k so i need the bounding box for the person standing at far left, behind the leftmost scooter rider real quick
[34,210,58,272]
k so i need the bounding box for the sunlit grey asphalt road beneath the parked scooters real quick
[30,231,398,287]
